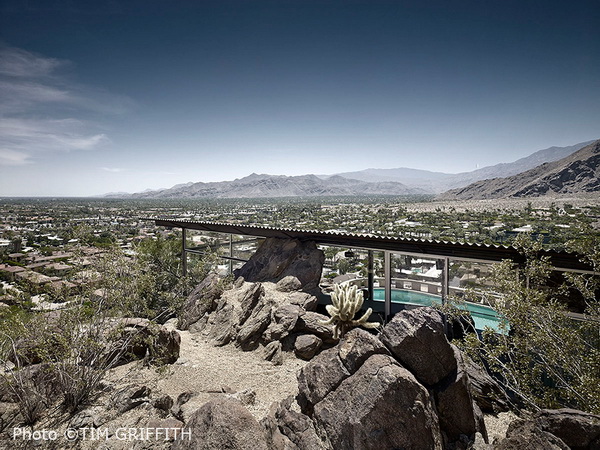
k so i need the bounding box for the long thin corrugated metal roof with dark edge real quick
[149,218,593,271]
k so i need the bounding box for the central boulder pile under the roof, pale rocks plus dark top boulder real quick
[178,239,337,364]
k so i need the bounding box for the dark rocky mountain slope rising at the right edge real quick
[439,140,600,200]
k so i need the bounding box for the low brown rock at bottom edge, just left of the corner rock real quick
[494,419,569,450]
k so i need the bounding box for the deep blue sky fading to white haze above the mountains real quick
[0,0,600,196]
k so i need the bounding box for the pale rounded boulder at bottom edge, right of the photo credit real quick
[172,398,268,450]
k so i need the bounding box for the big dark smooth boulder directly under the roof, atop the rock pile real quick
[234,238,325,291]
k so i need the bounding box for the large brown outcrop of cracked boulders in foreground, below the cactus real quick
[297,308,487,449]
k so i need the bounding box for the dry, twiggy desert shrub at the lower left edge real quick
[0,305,137,416]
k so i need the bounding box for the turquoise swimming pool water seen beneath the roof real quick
[373,288,500,330]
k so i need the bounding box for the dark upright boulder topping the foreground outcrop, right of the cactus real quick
[380,307,456,386]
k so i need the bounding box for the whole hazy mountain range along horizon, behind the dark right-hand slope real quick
[105,141,597,198]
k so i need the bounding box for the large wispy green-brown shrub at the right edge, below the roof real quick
[462,239,600,413]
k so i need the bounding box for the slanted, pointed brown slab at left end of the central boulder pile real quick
[177,272,223,330]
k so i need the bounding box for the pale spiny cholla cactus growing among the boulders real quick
[323,284,379,339]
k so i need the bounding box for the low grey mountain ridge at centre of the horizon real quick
[120,173,423,198]
